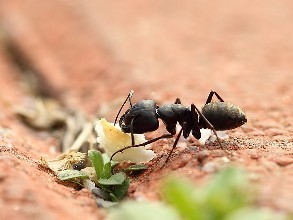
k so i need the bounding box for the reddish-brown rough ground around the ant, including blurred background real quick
[0,0,293,219]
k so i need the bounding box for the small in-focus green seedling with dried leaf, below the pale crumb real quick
[46,150,146,206]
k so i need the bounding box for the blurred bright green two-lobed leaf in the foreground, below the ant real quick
[163,167,253,220]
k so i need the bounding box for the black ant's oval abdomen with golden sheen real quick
[202,102,247,131]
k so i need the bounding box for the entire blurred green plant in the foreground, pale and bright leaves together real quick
[108,167,285,220]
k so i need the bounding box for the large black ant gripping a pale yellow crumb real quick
[111,90,247,166]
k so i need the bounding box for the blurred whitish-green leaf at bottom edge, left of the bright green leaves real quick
[107,201,181,220]
